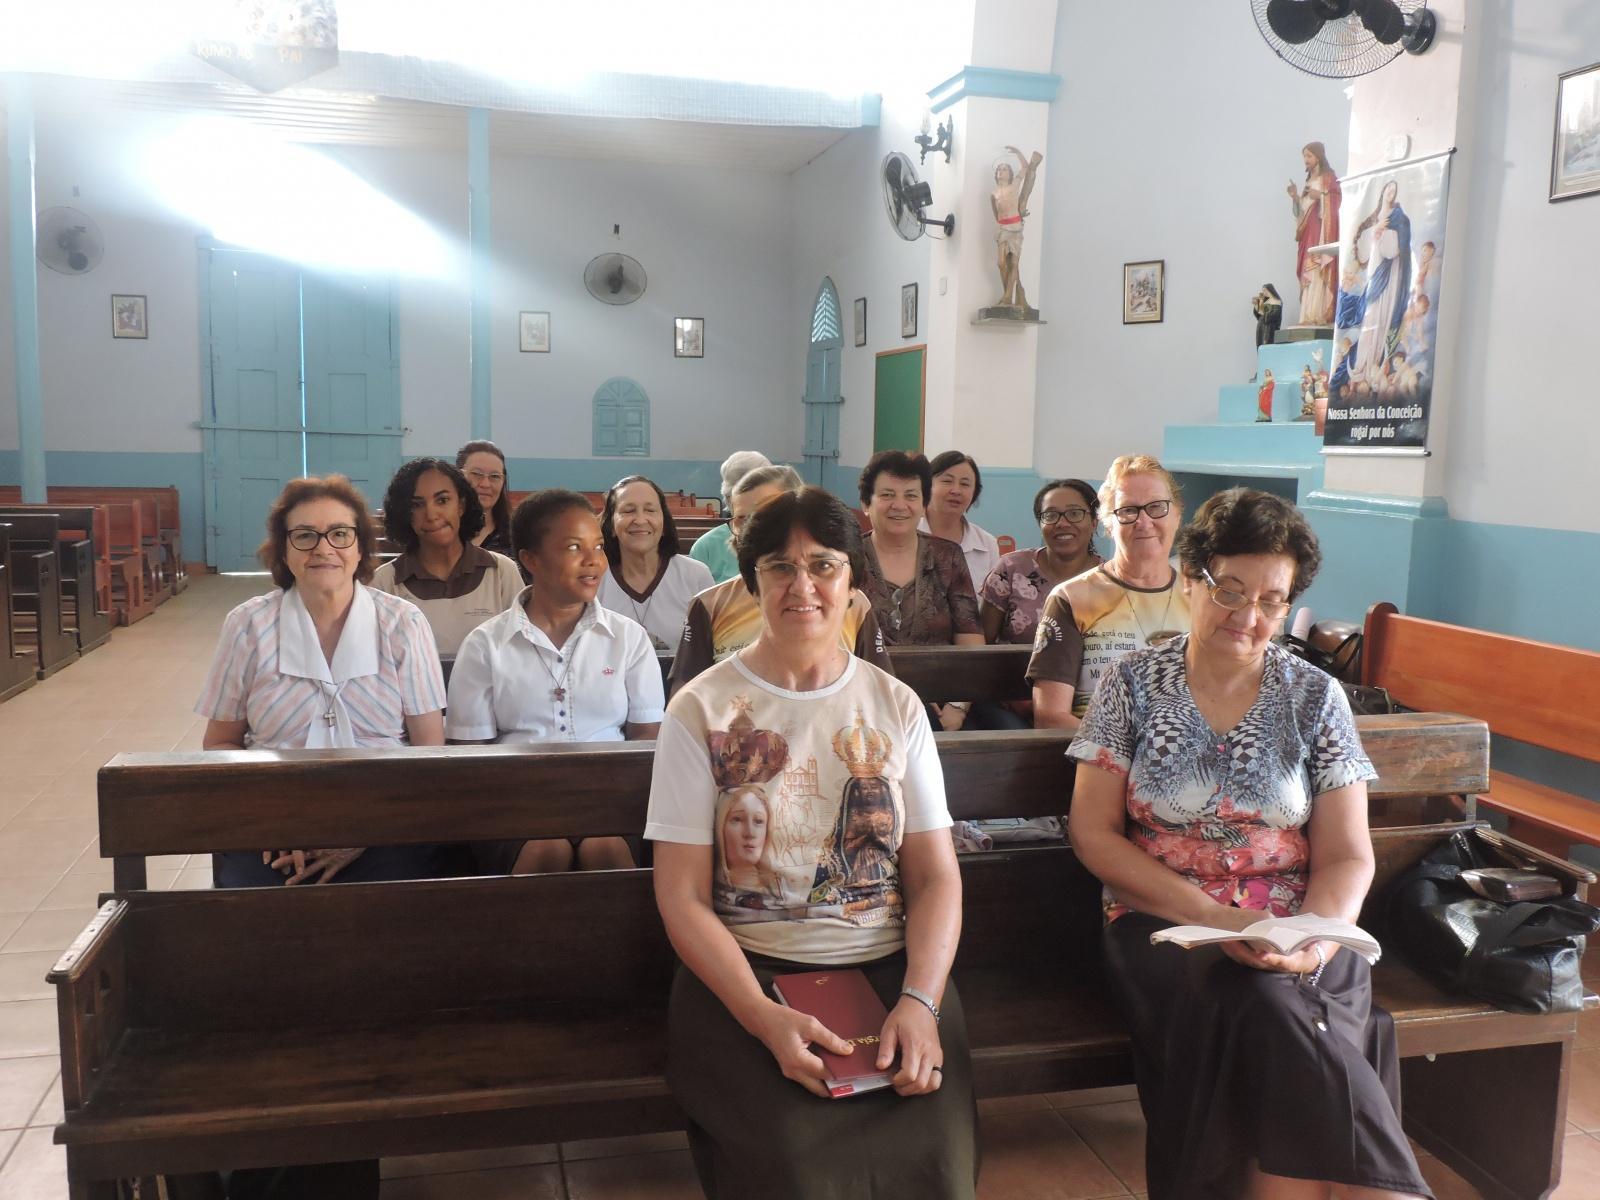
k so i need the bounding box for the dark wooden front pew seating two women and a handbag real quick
[51,715,1594,1197]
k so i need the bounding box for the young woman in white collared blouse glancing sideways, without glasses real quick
[446,488,664,875]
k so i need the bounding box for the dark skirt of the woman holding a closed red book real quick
[667,954,978,1200]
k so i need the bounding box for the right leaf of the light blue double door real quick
[301,270,403,509]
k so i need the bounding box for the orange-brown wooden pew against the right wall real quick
[1362,603,1600,854]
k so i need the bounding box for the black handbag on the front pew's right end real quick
[1382,832,1600,1013]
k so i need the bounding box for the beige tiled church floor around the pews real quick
[0,576,1600,1200]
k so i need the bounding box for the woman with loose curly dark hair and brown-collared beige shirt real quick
[373,458,522,674]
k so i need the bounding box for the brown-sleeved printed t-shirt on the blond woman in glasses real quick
[1027,563,1189,718]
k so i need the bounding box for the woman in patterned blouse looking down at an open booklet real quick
[1069,488,1430,1200]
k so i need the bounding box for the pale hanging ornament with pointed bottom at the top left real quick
[194,0,339,91]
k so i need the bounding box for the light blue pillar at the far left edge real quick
[6,74,45,504]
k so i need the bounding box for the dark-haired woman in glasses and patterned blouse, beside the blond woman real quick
[978,478,1101,645]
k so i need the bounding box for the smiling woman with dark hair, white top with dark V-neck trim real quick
[600,475,715,654]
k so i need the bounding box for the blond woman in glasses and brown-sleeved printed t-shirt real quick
[1027,454,1189,730]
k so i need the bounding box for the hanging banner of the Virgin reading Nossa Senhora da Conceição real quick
[1323,152,1450,454]
